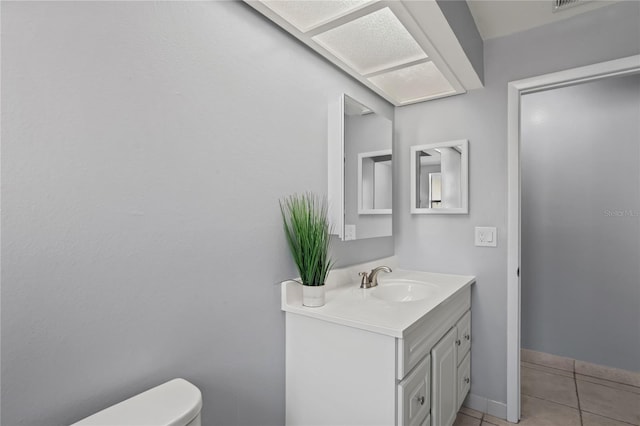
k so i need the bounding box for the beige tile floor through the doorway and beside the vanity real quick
[454,351,640,426]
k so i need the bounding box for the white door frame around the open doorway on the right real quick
[507,55,640,423]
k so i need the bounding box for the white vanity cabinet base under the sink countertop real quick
[286,287,471,426]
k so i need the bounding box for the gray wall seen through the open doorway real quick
[521,75,640,371]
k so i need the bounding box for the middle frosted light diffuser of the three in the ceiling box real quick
[312,7,427,75]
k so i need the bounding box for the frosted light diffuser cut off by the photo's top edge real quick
[262,0,375,33]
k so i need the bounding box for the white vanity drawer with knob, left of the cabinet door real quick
[398,355,431,426]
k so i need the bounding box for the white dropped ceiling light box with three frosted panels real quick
[244,0,482,106]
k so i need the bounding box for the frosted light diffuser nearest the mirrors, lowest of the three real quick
[369,62,455,104]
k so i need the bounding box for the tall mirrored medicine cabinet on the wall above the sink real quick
[329,95,393,241]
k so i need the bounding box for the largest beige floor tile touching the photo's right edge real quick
[577,380,640,425]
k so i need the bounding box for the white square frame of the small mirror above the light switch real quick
[410,139,469,214]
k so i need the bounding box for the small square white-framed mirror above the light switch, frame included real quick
[411,139,469,214]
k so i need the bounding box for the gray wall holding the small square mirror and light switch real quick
[394,2,640,412]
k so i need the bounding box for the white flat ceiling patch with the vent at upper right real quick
[467,0,619,40]
